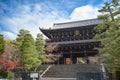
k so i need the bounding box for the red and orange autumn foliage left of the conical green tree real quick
[0,40,19,71]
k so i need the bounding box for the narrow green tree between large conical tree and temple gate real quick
[35,34,47,63]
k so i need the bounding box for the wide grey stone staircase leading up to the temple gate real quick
[42,64,101,80]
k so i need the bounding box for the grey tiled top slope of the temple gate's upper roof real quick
[52,19,103,29]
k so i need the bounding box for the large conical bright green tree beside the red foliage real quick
[20,34,41,70]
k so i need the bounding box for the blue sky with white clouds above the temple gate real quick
[0,0,110,40]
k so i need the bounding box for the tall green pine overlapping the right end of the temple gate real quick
[95,0,120,72]
